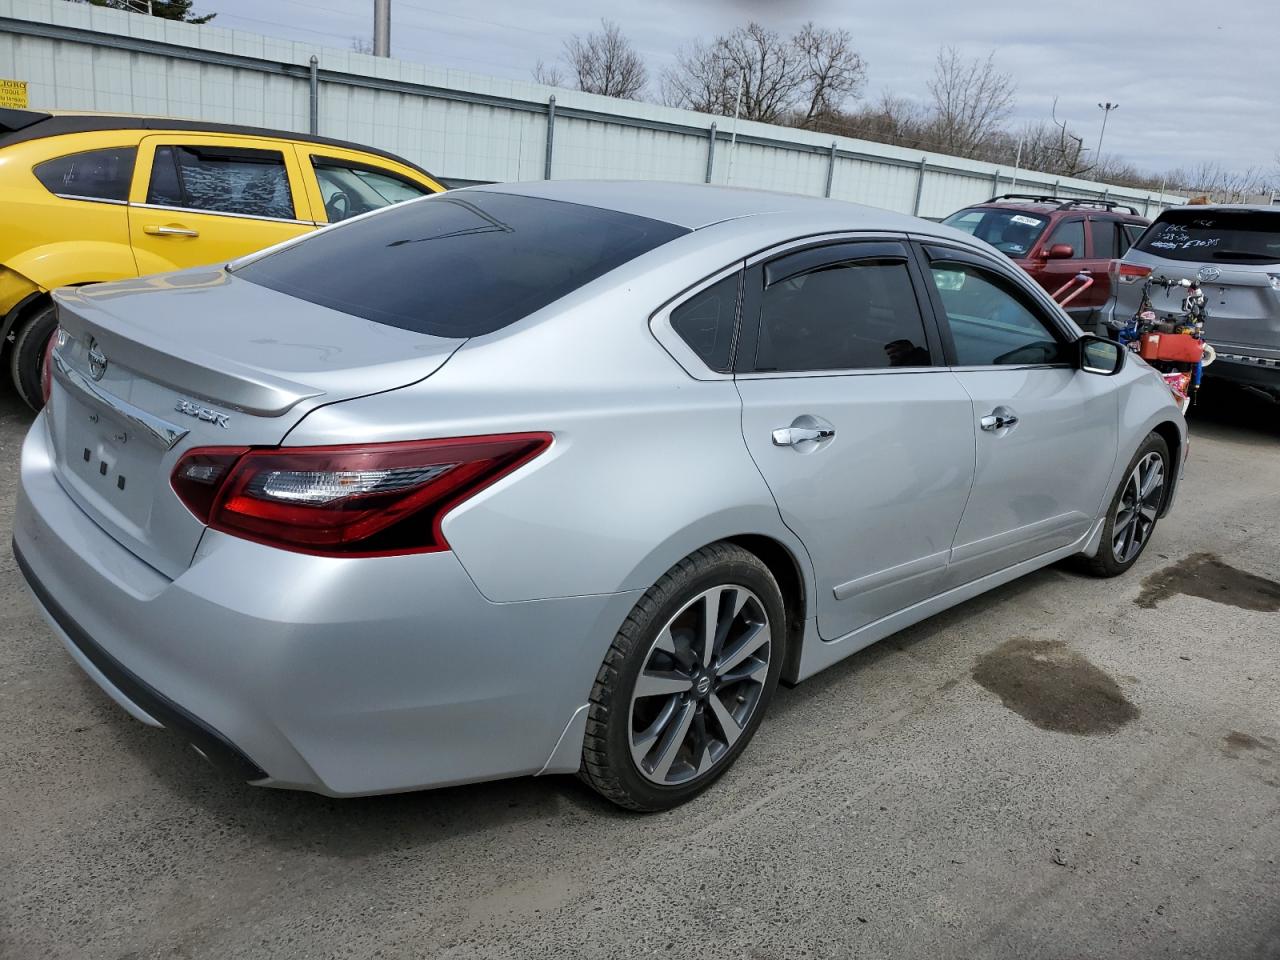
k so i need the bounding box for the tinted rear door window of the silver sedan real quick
[755,260,931,371]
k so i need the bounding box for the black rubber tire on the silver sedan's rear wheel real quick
[579,543,787,812]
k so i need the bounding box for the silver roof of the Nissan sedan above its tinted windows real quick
[453,180,973,235]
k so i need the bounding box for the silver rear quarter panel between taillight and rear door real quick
[285,242,812,611]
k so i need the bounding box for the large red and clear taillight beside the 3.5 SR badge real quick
[172,434,552,556]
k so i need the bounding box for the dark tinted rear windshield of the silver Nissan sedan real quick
[236,191,689,337]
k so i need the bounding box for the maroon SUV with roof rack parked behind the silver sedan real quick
[942,193,1151,329]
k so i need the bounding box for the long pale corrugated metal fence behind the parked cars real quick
[0,0,1183,218]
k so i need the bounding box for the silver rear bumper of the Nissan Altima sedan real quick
[13,416,637,796]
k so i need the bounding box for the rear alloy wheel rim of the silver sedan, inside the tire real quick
[630,584,772,786]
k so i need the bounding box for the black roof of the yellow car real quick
[0,109,439,180]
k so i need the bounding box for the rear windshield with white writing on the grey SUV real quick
[1134,207,1280,264]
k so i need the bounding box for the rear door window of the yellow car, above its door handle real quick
[147,146,293,220]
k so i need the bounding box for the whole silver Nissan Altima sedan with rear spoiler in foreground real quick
[14,182,1187,810]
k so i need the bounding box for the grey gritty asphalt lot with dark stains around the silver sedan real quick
[0,386,1280,960]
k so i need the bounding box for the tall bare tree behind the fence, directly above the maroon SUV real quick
[928,46,1014,157]
